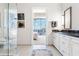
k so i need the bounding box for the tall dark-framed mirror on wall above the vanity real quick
[64,7,72,29]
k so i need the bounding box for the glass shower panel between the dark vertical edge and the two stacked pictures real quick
[9,9,17,55]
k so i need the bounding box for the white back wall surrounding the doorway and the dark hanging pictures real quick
[17,3,61,44]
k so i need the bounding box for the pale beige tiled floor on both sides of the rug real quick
[17,46,61,56]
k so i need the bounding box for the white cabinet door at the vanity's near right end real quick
[71,39,79,56]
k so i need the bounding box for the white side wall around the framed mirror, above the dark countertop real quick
[61,3,79,30]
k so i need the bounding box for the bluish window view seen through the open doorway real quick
[33,18,46,35]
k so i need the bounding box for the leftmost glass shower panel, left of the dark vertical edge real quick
[0,3,9,56]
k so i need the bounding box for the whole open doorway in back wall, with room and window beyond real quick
[32,9,47,45]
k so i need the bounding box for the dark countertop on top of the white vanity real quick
[53,30,79,38]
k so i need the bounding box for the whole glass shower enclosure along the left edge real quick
[0,3,17,56]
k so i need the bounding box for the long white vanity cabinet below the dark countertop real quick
[53,33,79,56]
